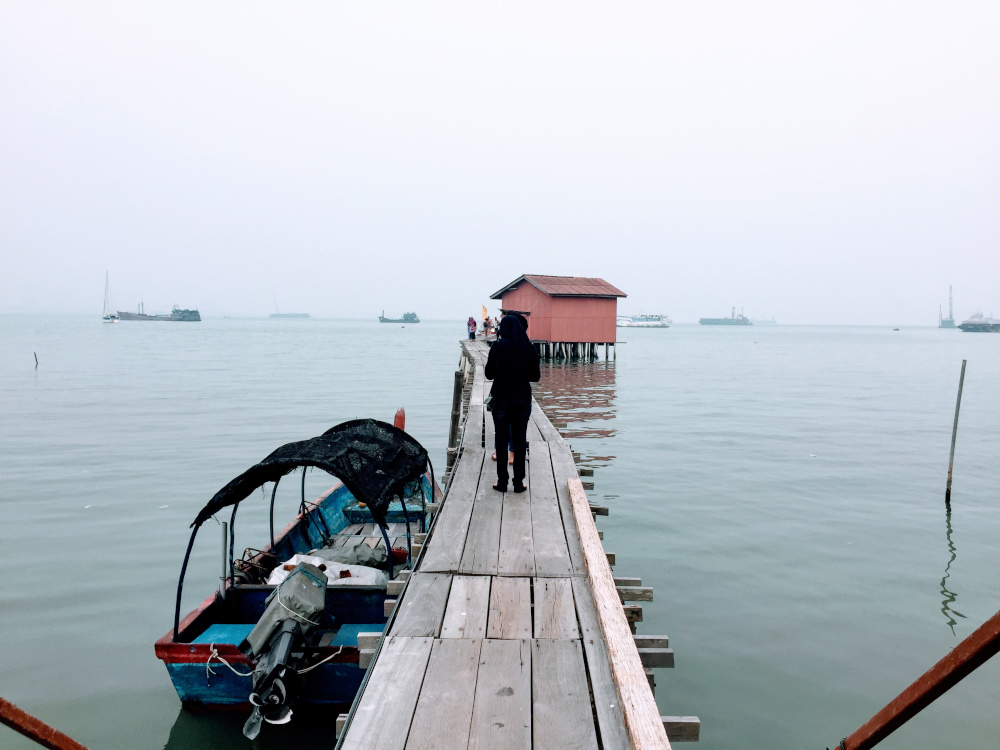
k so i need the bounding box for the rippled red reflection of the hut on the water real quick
[534,361,617,482]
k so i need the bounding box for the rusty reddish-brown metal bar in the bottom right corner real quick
[840,612,1000,750]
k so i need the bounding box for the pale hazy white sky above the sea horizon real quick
[0,0,1000,324]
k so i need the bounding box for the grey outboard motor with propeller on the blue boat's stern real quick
[240,563,326,740]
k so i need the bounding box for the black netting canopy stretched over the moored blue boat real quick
[191,419,427,527]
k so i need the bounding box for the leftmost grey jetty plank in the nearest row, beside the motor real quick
[341,637,433,750]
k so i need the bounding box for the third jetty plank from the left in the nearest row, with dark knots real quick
[469,640,531,750]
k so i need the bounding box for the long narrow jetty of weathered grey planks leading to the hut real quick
[337,341,700,750]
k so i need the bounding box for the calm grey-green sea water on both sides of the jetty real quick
[0,316,1000,750]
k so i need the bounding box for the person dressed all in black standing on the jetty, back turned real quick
[486,315,541,492]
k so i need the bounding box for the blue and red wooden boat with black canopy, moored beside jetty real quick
[155,419,435,739]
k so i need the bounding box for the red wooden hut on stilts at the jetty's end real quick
[490,274,626,356]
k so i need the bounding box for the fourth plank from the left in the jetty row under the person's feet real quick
[527,443,582,576]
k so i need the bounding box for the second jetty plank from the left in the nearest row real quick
[406,639,483,750]
